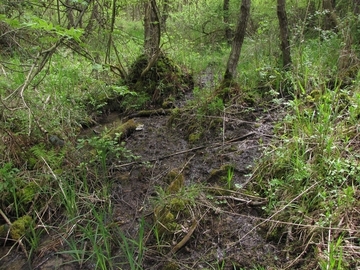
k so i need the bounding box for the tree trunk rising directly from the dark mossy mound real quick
[144,0,160,60]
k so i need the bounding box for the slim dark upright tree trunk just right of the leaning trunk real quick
[277,0,291,69]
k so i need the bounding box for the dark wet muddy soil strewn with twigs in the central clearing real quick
[109,106,281,269]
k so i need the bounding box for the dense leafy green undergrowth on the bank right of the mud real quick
[252,86,360,269]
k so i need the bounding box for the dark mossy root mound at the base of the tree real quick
[126,54,194,105]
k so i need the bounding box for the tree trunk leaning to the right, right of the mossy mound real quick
[224,0,251,82]
